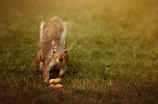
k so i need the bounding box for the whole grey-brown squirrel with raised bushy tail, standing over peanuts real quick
[36,17,68,82]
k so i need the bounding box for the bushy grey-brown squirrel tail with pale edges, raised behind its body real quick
[40,17,66,44]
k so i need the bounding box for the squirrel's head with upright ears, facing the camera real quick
[52,41,68,63]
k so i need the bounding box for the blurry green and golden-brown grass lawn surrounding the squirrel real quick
[0,0,158,104]
